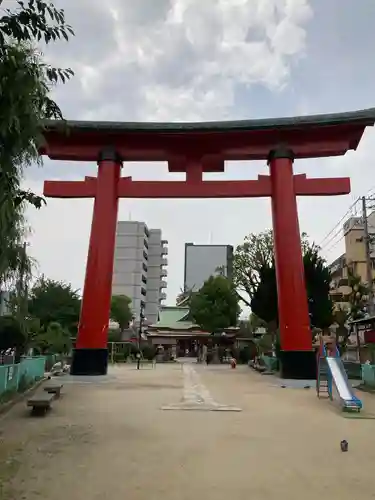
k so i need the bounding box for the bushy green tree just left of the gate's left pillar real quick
[28,276,81,335]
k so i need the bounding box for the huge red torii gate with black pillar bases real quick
[41,109,375,379]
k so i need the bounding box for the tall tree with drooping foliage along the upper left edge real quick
[0,0,73,292]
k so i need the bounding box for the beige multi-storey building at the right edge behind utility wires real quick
[329,212,375,308]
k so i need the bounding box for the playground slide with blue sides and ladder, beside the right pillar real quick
[316,337,362,412]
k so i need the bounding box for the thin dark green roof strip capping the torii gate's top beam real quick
[43,108,375,133]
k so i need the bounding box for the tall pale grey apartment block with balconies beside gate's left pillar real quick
[112,221,168,323]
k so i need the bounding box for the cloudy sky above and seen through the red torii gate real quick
[14,0,375,304]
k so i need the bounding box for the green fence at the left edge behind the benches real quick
[0,356,46,397]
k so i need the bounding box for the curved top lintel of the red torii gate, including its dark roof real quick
[40,108,375,162]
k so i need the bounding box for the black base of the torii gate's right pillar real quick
[280,351,316,380]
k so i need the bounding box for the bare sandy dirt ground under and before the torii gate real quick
[0,364,375,500]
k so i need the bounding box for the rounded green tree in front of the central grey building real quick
[190,276,241,334]
